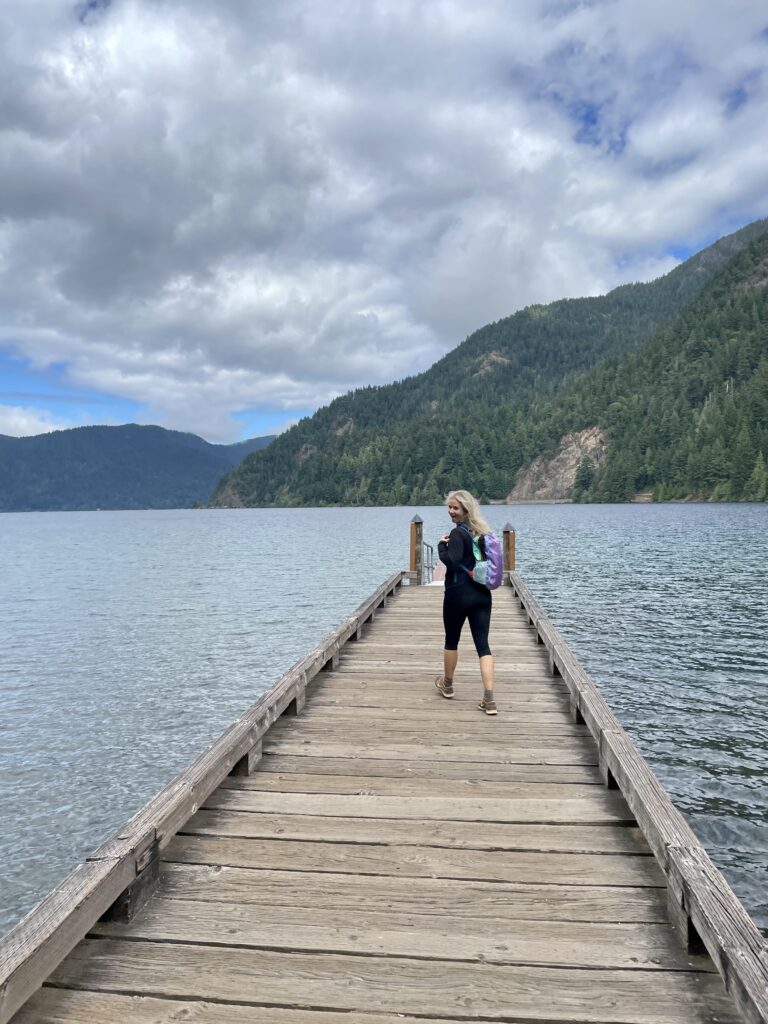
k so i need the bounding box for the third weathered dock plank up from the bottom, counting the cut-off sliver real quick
[93,896,714,973]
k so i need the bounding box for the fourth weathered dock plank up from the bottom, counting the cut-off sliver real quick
[162,862,669,924]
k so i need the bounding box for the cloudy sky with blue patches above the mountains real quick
[0,0,768,441]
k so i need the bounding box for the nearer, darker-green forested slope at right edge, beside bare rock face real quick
[548,233,768,501]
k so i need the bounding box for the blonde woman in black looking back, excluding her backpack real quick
[435,490,497,715]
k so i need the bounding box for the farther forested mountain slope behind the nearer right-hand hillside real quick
[211,220,768,506]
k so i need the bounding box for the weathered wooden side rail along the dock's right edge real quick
[509,571,768,1024]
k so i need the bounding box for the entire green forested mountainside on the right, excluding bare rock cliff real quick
[211,221,768,506]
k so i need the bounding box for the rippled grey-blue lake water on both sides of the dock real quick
[0,505,768,932]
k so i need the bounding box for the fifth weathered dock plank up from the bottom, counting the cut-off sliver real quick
[166,835,665,888]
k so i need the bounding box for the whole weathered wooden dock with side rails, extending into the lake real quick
[0,561,768,1024]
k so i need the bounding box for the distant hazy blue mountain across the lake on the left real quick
[0,424,272,512]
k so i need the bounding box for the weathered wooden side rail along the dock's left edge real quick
[0,571,408,1024]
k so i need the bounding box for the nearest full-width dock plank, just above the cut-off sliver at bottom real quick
[46,939,734,1024]
